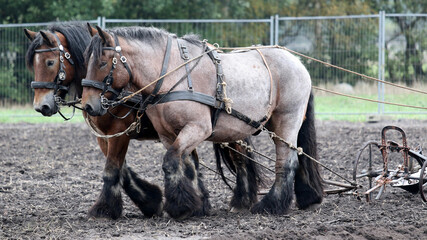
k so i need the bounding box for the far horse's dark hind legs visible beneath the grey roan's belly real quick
[214,137,263,209]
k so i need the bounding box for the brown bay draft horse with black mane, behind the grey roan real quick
[25,23,261,219]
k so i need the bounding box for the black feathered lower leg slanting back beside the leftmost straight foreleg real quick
[121,165,163,217]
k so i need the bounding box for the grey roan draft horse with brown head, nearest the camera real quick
[82,27,323,219]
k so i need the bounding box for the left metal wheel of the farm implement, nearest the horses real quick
[353,141,384,201]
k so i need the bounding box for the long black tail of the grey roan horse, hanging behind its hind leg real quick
[295,93,323,209]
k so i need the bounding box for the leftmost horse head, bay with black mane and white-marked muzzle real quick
[24,24,90,116]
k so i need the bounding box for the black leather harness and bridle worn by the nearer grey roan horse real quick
[82,35,268,135]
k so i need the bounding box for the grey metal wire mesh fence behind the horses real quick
[0,12,427,116]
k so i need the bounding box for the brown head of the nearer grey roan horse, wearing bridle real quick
[82,26,132,116]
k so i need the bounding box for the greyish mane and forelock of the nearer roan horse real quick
[84,26,202,64]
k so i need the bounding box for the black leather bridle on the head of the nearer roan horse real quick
[82,35,133,109]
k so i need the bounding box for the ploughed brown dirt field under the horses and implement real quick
[0,120,427,240]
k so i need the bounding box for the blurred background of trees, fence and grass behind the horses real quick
[0,0,427,122]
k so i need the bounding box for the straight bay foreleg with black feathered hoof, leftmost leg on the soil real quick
[88,136,130,219]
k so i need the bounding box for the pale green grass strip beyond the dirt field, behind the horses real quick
[0,82,427,123]
